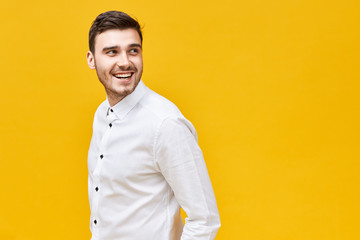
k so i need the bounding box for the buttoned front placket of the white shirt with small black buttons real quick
[91,108,116,236]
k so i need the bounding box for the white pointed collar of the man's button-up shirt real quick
[106,80,146,119]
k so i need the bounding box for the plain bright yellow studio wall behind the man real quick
[0,0,360,240]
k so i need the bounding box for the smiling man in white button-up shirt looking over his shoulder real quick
[87,11,220,240]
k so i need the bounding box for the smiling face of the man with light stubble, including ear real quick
[87,28,143,106]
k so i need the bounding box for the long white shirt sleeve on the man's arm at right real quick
[154,118,220,240]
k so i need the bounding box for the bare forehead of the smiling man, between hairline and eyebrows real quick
[95,28,141,51]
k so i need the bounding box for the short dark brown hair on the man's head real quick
[89,11,143,54]
